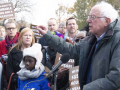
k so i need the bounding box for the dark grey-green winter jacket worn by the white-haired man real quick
[43,18,120,90]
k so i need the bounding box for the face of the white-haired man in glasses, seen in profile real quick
[87,7,107,37]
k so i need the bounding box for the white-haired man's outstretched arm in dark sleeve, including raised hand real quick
[37,26,80,59]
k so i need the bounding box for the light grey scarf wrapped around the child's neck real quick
[17,65,44,80]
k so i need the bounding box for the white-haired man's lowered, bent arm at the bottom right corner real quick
[83,42,120,90]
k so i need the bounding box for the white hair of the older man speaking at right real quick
[93,1,119,22]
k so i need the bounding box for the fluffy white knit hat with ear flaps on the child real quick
[20,43,43,70]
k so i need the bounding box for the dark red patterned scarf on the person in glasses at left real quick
[5,33,20,51]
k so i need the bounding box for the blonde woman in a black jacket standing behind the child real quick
[6,28,35,90]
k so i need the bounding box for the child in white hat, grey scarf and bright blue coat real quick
[17,43,50,90]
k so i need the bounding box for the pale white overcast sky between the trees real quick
[17,0,76,25]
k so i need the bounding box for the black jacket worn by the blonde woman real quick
[6,47,23,90]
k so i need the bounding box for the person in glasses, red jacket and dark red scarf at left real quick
[0,19,19,88]
